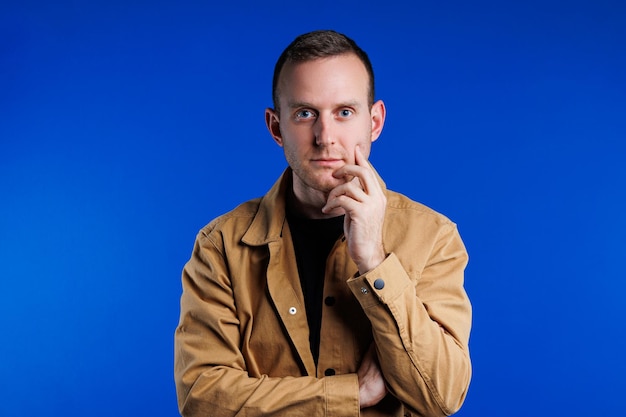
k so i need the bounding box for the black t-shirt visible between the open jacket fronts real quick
[287,209,344,365]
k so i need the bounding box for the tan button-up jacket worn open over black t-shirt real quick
[175,169,471,417]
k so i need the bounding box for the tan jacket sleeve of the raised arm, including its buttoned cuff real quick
[348,223,471,416]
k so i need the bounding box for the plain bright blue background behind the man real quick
[0,0,626,417]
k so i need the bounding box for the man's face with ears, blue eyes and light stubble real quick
[266,54,384,195]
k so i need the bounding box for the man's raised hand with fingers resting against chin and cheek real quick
[322,146,387,274]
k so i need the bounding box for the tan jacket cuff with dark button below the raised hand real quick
[347,253,411,309]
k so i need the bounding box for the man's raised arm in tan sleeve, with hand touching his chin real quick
[323,148,471,416]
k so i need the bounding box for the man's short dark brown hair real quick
[272,30,374,110]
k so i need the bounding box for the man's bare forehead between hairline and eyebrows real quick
[278,54,369,106]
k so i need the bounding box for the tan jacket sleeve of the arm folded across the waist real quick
[174,233,359,417]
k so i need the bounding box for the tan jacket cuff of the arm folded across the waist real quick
[324,374,360,417]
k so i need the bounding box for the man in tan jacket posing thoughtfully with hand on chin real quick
[175,31,471,417]
